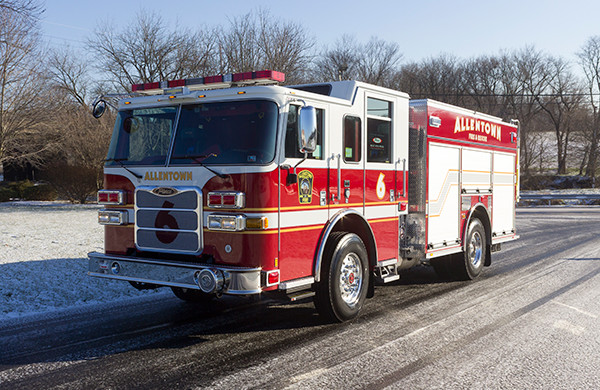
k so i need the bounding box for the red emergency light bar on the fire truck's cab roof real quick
[131,70,285,95]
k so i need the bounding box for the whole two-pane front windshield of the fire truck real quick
[106,100,278,165]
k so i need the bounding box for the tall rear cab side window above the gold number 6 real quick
[367,98,392,163]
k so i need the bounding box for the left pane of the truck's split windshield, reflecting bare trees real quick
[106,107,177,165]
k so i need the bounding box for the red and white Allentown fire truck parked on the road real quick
[88,71,519,321]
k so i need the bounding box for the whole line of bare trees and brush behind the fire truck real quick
[0,0,600,201]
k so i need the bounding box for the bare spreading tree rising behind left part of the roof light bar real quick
[88,12,216,91]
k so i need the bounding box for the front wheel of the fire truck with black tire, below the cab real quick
[314,232,370,322]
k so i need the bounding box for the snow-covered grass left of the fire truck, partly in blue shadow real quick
[0,202,156,321]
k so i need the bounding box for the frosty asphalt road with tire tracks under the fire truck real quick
[0,207,600,389]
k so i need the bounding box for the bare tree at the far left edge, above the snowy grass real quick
[0,1,55,178]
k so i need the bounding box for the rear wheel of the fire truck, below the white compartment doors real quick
[453,218,487,280]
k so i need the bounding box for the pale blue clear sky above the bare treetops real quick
[41,0,600,65]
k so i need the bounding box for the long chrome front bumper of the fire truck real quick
[88,252,262,295]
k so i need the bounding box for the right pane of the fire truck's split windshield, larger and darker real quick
[171,100,278,165]
